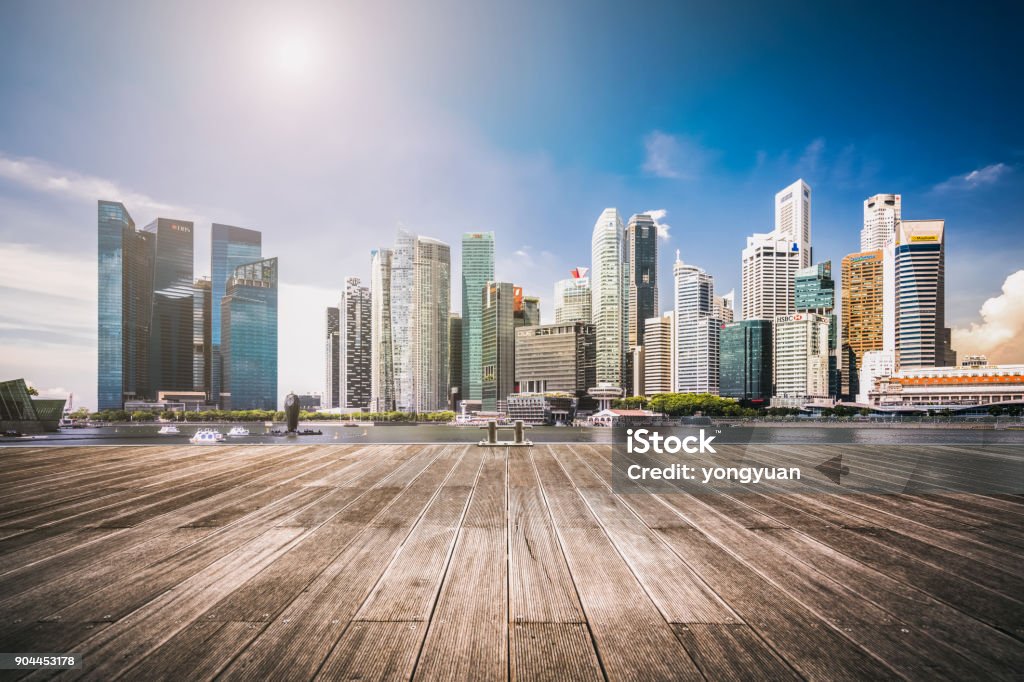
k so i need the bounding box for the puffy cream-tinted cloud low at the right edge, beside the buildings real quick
[953,269,1024,364]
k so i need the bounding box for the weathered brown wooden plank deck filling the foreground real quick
[0,444,1024,680]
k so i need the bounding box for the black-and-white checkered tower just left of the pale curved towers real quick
[338,278,373,409]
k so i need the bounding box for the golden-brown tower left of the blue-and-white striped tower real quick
[842,249,885,395]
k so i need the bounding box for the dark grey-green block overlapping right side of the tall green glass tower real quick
[480,282,523,412]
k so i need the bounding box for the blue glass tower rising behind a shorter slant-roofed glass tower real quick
[210,222,263,402]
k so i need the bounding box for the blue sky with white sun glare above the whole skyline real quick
[0,0,1024,404]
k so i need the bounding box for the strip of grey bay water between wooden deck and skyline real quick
[6,423,1024,445]
